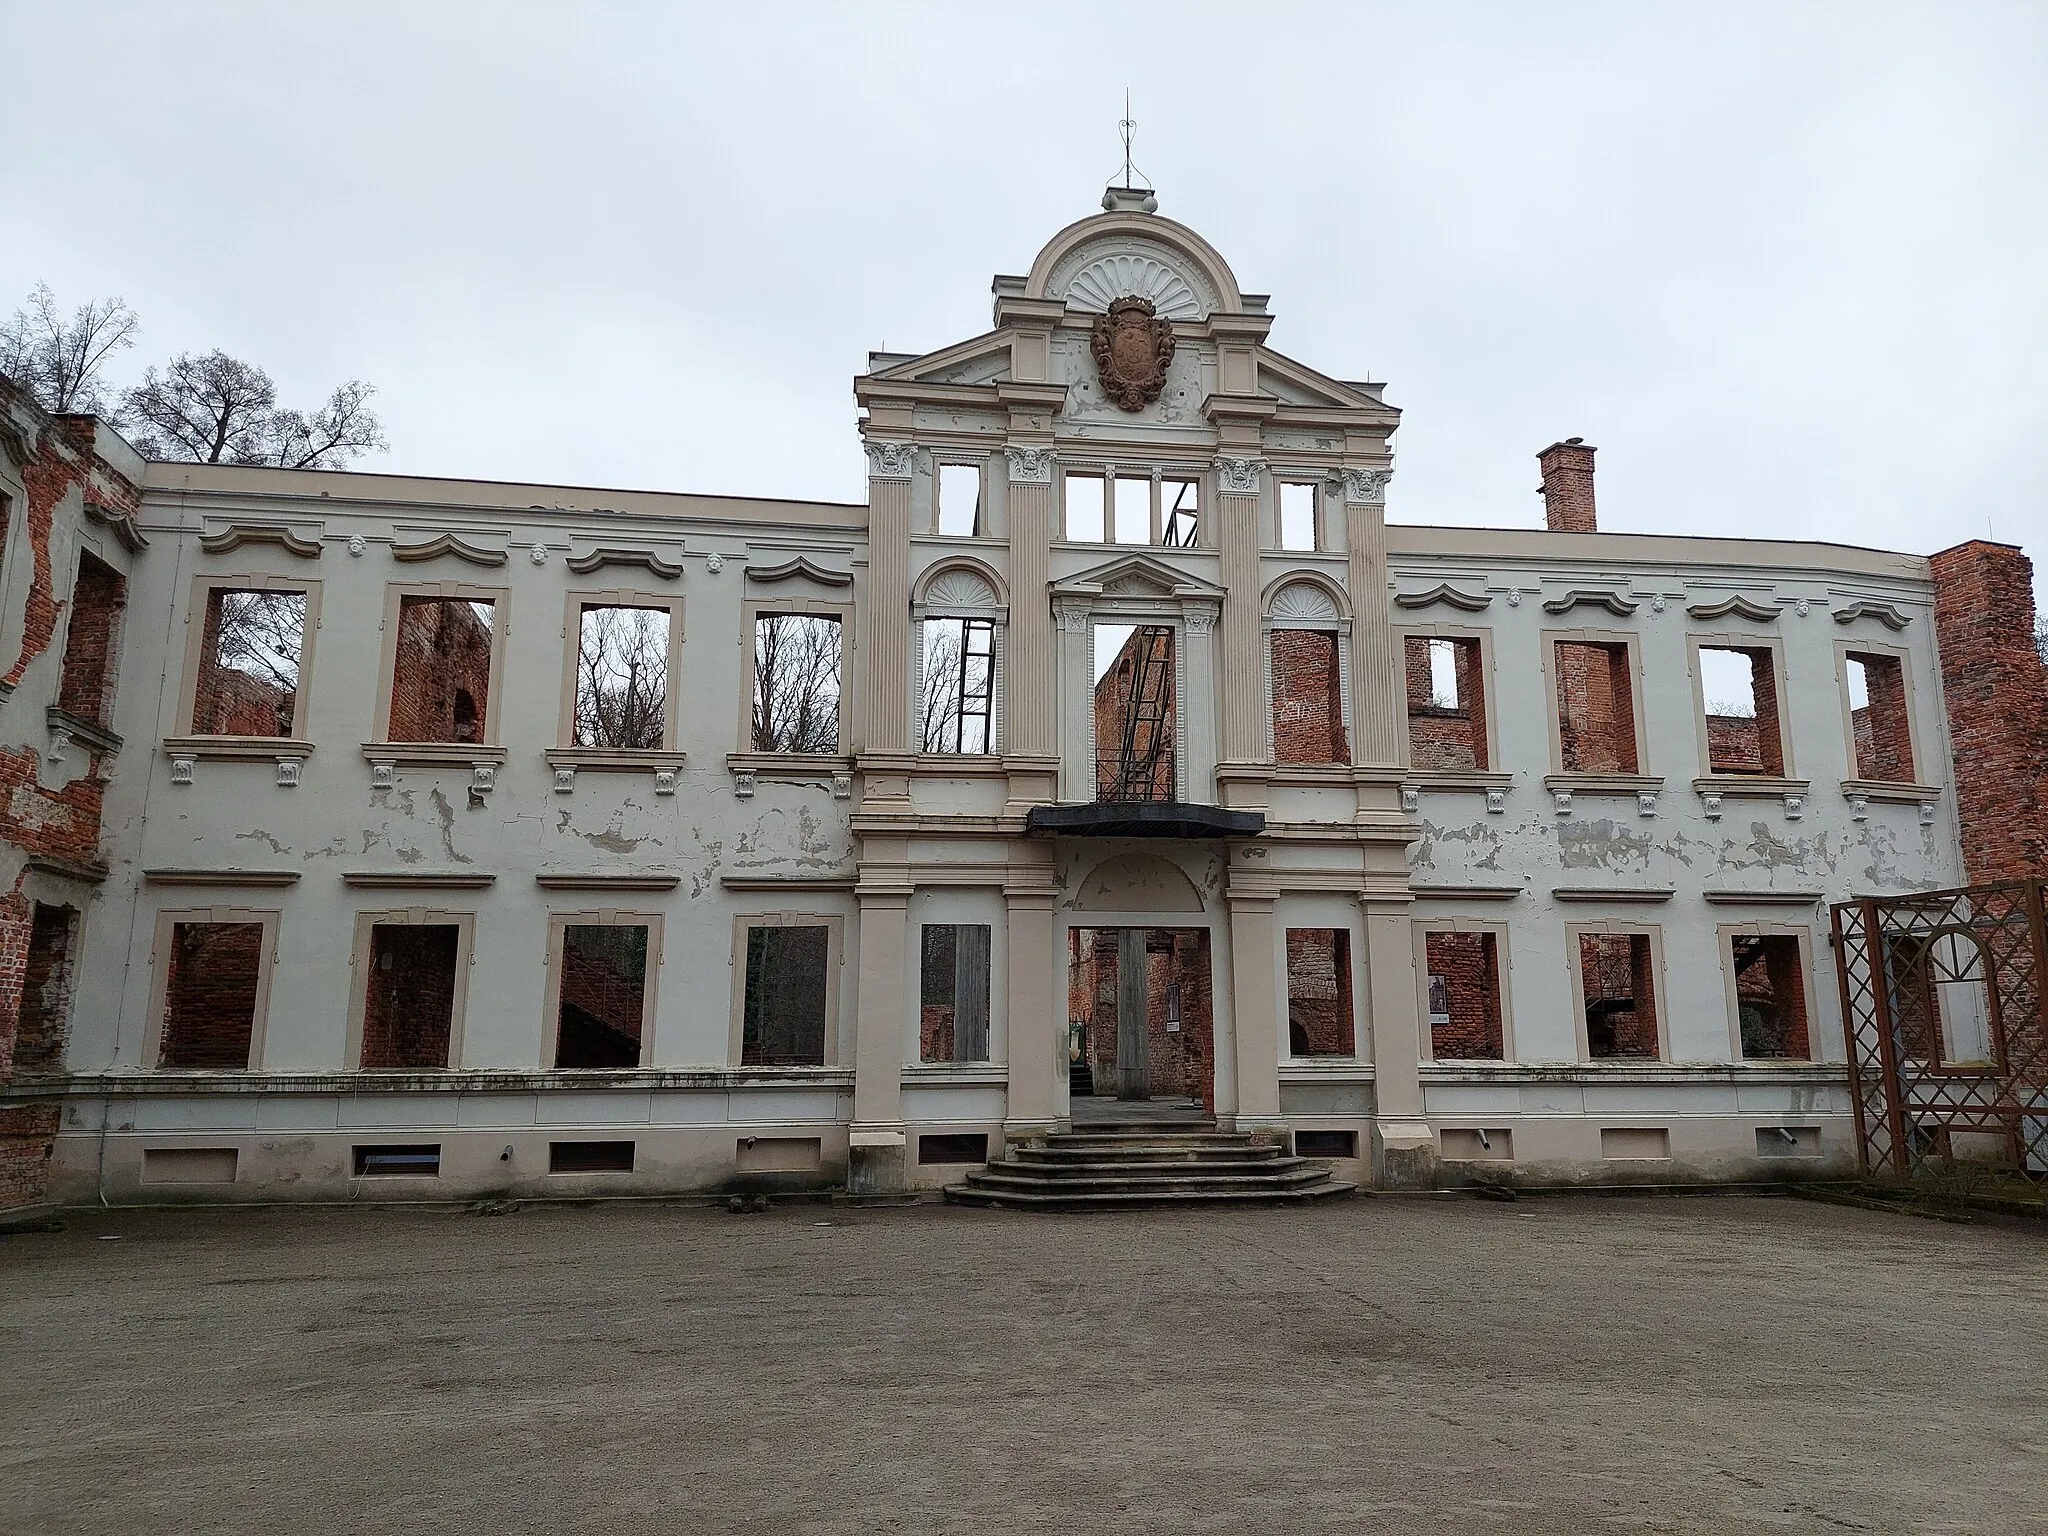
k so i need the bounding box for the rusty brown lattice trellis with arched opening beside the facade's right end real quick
[1833,881,2048,1176]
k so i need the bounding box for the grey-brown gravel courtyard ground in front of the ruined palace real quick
[0,1198,2048,1536]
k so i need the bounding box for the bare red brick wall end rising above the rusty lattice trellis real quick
[1931,539,2048,883]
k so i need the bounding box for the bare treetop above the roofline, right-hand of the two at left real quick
[119,348,387,469]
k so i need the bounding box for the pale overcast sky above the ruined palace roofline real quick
[0,0,2048,598]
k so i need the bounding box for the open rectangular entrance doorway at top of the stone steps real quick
[1067,928,1217,1120]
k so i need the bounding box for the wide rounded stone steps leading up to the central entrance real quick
[946,1120,1358,1210]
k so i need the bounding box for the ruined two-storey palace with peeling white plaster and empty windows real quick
[0,188,2040,1202]
